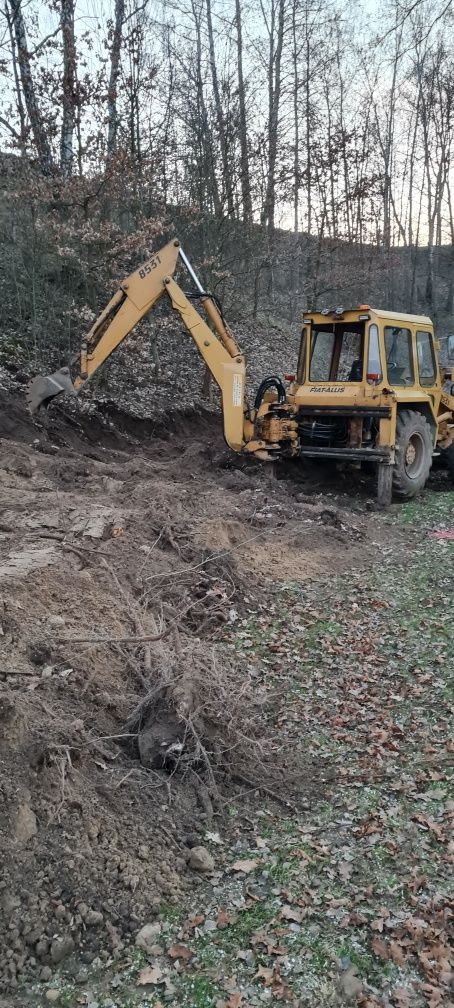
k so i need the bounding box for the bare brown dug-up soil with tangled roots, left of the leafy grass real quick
[0,390,415,989]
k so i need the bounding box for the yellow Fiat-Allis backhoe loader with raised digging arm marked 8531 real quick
[27,234,454,506]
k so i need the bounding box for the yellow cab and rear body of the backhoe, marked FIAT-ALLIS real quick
[290,304,438,462]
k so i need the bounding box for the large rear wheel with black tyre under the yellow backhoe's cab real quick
[392,409,433,498]
